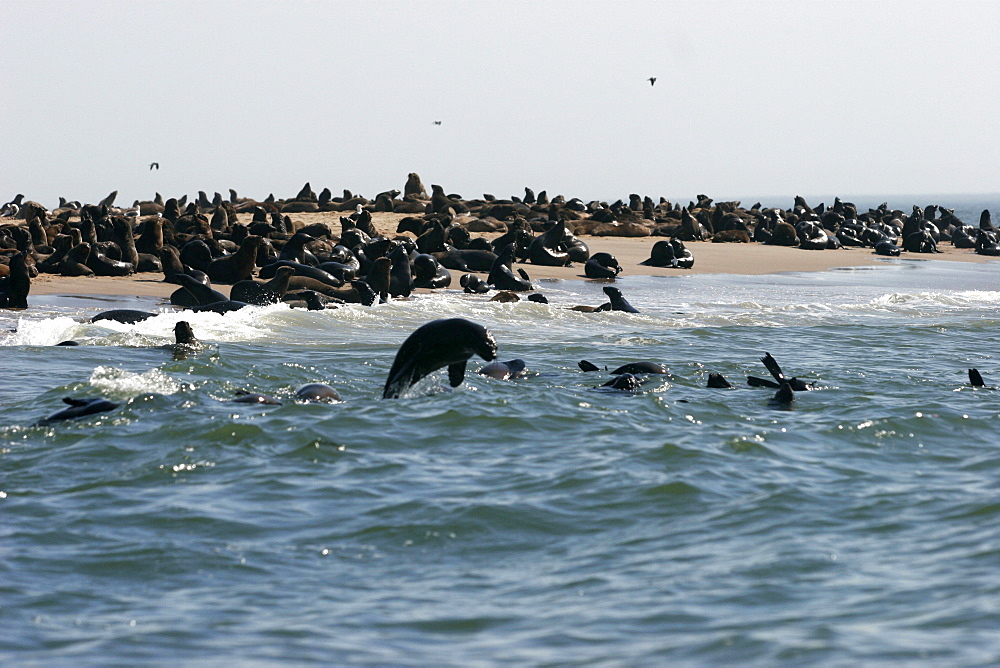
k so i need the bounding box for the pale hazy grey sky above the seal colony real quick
[0,0,1000,208]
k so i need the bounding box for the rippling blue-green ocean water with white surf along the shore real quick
[0,259,1000,665]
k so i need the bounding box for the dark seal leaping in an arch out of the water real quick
[382,318,497,399]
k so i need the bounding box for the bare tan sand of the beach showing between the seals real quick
[23,212,992,299]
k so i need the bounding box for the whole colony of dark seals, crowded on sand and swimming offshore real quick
[0,173,1000,419]
